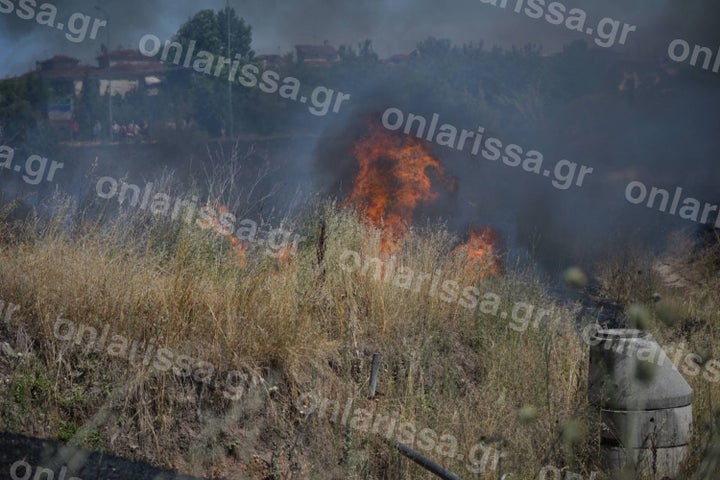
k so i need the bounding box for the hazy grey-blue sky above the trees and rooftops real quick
[0,0,695,77]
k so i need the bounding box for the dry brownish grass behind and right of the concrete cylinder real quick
[598,232,720,480]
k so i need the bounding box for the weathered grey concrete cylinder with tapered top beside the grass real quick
[588,329,693,480]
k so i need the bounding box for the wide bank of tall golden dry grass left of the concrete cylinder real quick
[0,194,720,479]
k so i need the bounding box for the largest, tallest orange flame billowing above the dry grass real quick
[345,124,454,253]
